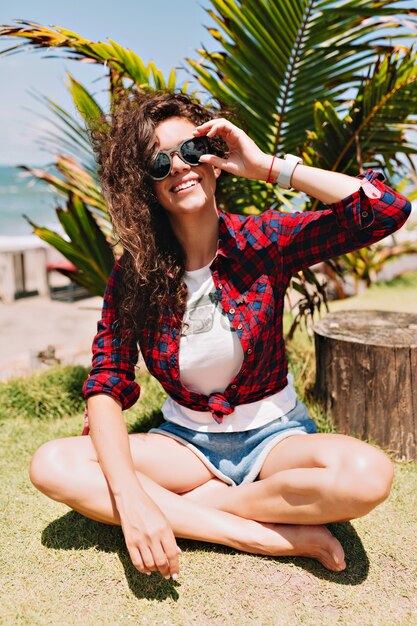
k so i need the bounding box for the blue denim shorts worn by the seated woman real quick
[149,400,317,487]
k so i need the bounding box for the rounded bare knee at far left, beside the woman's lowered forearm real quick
[29,439,78,501]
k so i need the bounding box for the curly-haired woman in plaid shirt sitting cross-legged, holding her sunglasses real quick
[30,92,410,580]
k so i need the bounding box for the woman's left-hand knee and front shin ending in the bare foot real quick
[31,437,345,571]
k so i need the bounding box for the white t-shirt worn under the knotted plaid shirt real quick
[162,263,297,432]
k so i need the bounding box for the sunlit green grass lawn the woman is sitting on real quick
[0,274,417,626]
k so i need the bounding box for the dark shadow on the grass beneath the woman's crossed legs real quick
[42,511,369,601]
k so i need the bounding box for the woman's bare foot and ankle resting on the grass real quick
[246,522,346,572]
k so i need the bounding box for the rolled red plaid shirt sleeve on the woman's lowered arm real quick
[83,257,140,410]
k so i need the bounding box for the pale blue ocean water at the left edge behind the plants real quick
[0,165,64,236]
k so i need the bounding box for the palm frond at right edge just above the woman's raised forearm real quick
[303,49,417,209]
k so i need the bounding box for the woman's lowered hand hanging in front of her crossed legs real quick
[116,490,181,580]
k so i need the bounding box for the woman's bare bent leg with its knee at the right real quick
[182,434,393,524]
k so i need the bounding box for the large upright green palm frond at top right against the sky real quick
[190,0,417,153]
